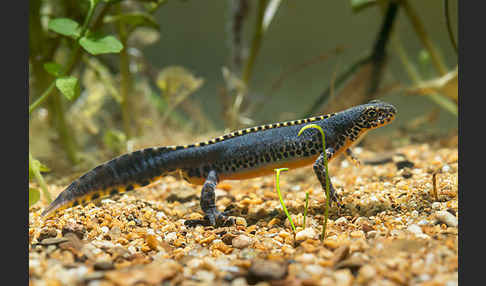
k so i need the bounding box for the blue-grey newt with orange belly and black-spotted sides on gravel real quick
[41,100,397,226]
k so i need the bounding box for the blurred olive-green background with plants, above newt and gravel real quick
[29,0,458,202]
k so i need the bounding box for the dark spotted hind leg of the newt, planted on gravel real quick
[184,170,234,227]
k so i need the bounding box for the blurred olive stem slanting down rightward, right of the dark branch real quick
[401,0,447,75]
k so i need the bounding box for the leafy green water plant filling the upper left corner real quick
[29,0,166,169]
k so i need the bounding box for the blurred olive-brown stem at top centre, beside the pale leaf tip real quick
[242,0,268,86]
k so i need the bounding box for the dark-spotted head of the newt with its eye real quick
[355,99,397,130]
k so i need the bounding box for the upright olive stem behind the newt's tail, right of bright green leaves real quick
[118,4,133,139]
